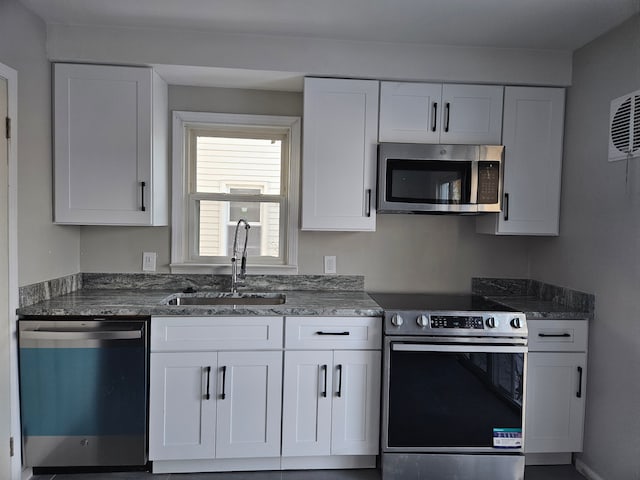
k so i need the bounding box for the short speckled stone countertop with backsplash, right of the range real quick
[471,278,595,320]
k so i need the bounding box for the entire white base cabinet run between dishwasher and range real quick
[149,316,381,473]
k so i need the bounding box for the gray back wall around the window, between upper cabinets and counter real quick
[80,86,528,292]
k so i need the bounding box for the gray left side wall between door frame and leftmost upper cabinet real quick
[0,0,80,285]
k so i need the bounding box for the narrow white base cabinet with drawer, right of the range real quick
[525,320,588,463]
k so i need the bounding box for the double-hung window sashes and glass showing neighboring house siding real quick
[189,132,288,263]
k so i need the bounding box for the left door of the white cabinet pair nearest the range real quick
[282,350,333,457]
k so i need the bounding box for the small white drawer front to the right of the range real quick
[527,320,589,352]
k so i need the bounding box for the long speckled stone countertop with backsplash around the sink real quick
[18,274,382,316]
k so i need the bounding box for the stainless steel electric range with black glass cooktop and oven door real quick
[371,293,528,480]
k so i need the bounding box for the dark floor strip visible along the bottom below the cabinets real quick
[32,465,584,480]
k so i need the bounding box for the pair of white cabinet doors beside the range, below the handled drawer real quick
[282,351,381,457]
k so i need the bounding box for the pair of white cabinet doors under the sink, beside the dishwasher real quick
[149,352,282,460]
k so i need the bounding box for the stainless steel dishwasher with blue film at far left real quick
[18,317,148,467]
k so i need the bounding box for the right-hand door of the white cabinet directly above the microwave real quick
[440,85,504,145]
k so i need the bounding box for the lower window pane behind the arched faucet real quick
[198,200,281,261]
